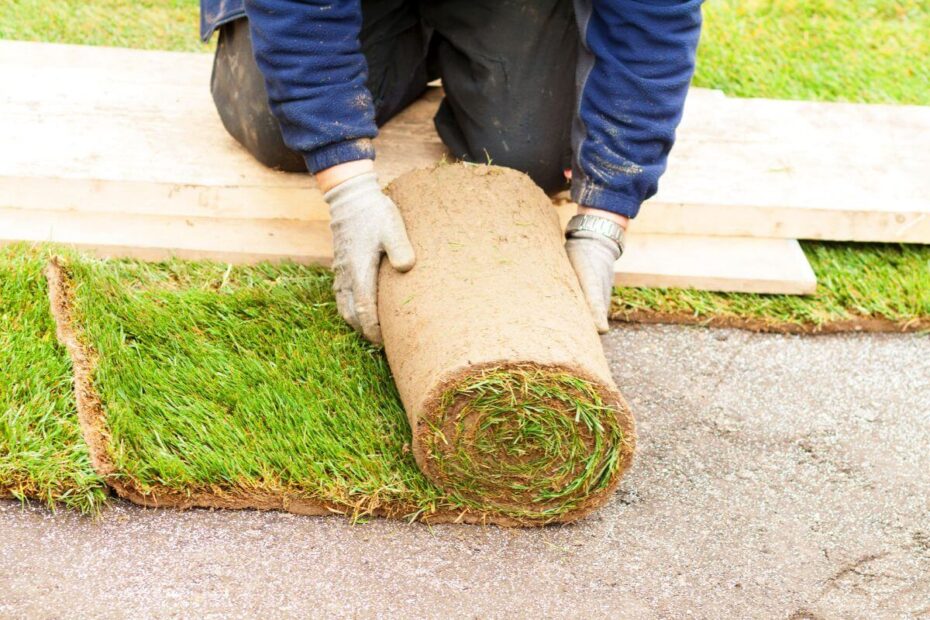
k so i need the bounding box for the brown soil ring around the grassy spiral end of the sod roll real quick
[412,360,636,525]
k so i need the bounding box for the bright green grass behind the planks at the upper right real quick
[694,0,930,105]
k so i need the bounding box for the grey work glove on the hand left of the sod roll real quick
[324,172,416,344]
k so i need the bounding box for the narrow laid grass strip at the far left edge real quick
[0,245,106,513]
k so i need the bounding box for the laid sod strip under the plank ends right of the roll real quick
[612,241,930,333]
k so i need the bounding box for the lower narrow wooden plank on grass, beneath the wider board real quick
[0,208,816,294]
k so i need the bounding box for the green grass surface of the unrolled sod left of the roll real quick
[59,258,441,514]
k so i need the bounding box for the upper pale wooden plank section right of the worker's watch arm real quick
[637,92,930,243]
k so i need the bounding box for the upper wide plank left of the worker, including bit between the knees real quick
[0,41,445,220]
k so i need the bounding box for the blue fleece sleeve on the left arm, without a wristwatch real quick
[245,0,378,172]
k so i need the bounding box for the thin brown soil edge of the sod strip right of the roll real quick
[610,310,930,336]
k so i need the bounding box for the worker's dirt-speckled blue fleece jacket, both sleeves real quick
[201,0,702,217]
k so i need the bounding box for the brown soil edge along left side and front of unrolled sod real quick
[45,257,588,527]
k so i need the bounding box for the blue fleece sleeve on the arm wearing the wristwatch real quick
[572,0,701,217]
